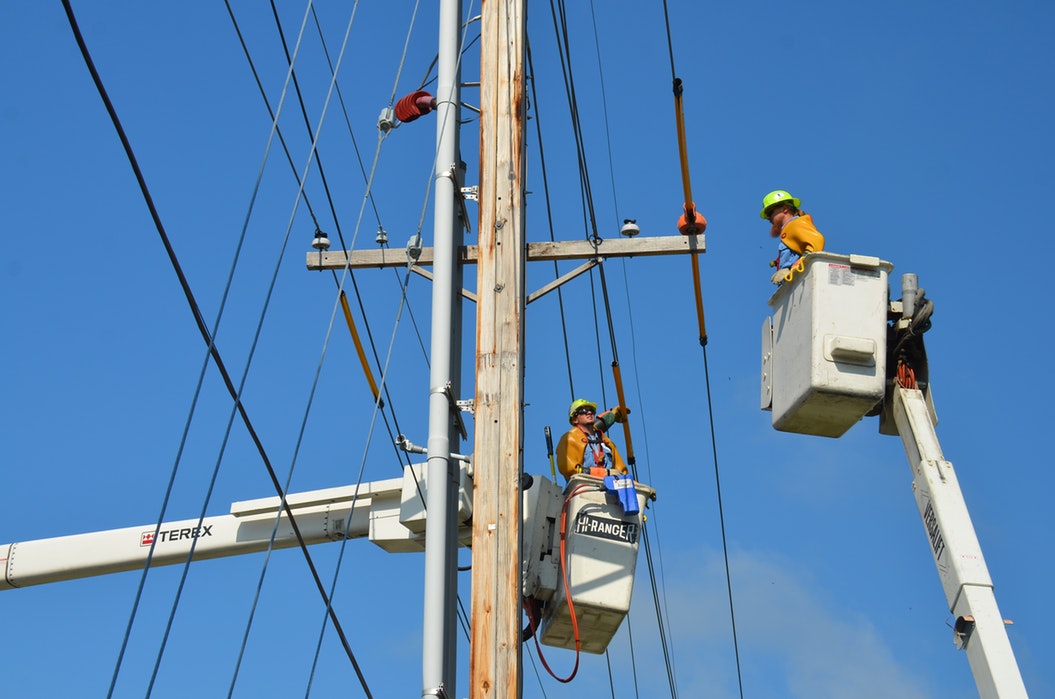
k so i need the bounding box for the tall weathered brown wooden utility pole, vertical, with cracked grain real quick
[469,0,526,699]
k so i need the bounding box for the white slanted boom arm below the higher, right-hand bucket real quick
[894,386,1028,699]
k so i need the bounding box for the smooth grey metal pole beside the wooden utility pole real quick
[421,0,461,697]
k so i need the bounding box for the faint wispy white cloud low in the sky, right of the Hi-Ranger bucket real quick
[620,550,932,699]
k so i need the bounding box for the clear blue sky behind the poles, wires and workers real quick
[0,0,1055,698]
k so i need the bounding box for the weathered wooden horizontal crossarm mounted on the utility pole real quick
[306,235,706,271]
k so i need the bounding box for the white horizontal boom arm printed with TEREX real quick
[0,463,472,590]
